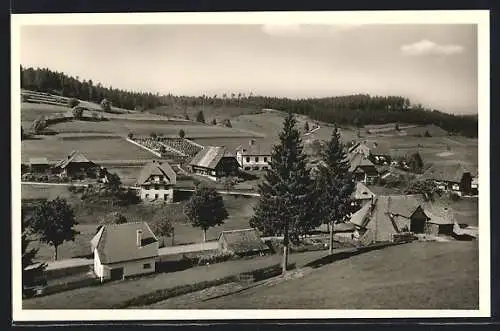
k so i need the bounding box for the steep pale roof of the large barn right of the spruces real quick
[349,195,424,241]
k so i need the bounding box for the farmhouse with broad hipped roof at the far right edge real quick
[423,163,477,195]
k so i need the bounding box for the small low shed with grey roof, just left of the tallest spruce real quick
[219,229,269,256]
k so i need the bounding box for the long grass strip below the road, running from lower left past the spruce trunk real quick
[23,251,325,309]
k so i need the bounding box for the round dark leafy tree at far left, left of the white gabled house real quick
[29,197,78,260]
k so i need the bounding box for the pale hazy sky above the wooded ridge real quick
[20,24,478,114]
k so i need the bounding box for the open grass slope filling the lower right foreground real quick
[171,242,479,309]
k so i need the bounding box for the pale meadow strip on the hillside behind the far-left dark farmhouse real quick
[21,137,154,162]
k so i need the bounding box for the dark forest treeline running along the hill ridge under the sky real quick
[21,68,478,137]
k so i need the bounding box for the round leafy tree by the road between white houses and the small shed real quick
[184,184,229,242]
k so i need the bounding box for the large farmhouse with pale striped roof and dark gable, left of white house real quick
[189,146,239,180]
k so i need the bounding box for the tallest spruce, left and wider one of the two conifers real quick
[250,112,314,272]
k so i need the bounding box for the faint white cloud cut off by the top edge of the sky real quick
[262,24,362,36]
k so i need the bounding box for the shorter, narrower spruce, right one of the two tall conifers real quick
[315,126,355,254]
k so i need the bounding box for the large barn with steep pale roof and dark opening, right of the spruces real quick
[349,195,428,242]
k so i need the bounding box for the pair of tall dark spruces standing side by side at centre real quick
[250,112,355,272]
